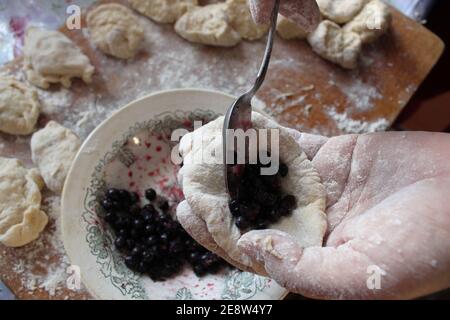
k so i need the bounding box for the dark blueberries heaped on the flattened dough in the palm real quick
[229,161,297,231]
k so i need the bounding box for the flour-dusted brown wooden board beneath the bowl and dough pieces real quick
[0,1,444,299]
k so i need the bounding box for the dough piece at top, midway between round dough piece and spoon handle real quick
[175,3,241,47]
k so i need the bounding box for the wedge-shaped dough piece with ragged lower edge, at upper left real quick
[24,27,94,89]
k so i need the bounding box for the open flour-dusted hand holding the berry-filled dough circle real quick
[178,129,450,299]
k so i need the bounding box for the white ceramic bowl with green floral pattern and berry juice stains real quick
[61,89,286,300]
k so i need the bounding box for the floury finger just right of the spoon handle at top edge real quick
[280,0,321,32]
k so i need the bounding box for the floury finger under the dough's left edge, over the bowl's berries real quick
[177,200,253,272]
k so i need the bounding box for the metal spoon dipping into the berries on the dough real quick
[223,0,280,198]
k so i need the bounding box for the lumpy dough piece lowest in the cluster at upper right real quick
[308,20,362,69]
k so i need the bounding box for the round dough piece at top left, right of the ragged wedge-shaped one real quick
[86,3,144,59]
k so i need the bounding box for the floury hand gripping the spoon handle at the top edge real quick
[248,0,320,32]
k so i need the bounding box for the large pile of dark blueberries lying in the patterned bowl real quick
[100,188,227,281]
